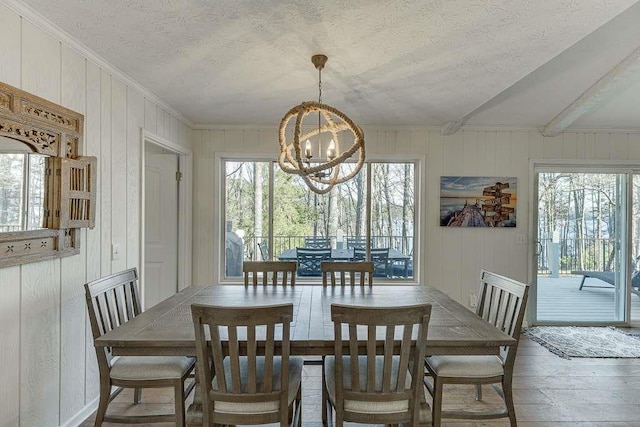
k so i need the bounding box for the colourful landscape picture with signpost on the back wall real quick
[440,176,517,227]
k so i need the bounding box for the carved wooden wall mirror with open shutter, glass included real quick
[0,82,97,267]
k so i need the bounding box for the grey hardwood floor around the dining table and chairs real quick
[82,336,640,427]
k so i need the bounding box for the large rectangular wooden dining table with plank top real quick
[94,284,515,425]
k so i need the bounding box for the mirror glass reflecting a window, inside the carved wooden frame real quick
[0,136,47,233]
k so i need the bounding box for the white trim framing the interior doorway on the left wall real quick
[139,128,193,300]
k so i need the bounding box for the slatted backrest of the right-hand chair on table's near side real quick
[331,304,431,419]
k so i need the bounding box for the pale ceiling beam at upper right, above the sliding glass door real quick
[542,47,640,136]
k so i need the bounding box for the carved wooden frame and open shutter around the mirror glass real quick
[0,82,97,267]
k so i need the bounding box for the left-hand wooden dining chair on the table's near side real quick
[191,304,303,427]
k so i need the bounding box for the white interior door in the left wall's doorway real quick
[144,150,178,309]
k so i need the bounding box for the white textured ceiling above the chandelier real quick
[17,0,640,127]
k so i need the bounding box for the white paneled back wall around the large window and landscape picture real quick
[193,126,640,305]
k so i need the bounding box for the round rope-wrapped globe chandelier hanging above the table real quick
[278,55,365,194]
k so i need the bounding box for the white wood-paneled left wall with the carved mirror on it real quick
[0,1,191,427]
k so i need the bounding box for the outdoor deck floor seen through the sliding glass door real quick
[537,276,640,323]
